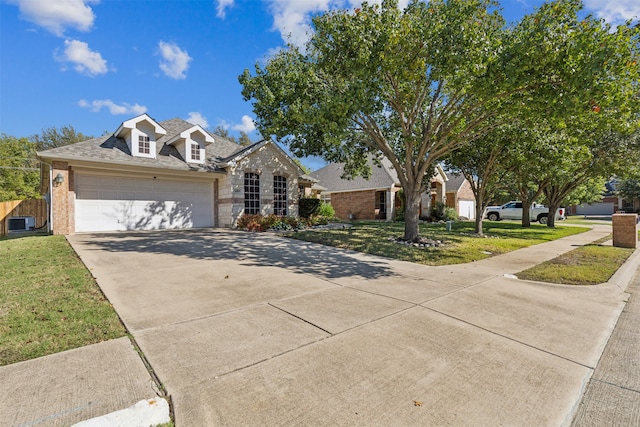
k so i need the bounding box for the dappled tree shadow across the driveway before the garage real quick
[74,229,395,279]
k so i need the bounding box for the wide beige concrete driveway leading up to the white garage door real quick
[68,230,627,426]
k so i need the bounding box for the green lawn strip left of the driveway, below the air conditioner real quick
[0,236,126,365]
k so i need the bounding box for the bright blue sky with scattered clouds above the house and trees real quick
[0,0,640,169]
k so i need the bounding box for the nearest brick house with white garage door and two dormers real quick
[38,114,314,234]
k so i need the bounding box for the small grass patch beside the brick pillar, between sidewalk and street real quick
[517,236,634,285]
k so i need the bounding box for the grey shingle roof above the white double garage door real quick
[38,118,250,172]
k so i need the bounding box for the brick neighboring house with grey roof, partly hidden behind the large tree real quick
[311,158,447,221]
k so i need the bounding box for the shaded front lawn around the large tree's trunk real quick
[289,222,588,265]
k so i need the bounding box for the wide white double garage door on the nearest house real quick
[75,174,213,232]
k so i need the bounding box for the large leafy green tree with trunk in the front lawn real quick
[239,0,639,240]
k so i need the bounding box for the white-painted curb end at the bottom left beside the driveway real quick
[73,397,171,427]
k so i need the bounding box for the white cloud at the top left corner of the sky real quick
[11,0,100,37]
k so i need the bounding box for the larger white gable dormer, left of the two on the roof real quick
[114,114,167,159]
